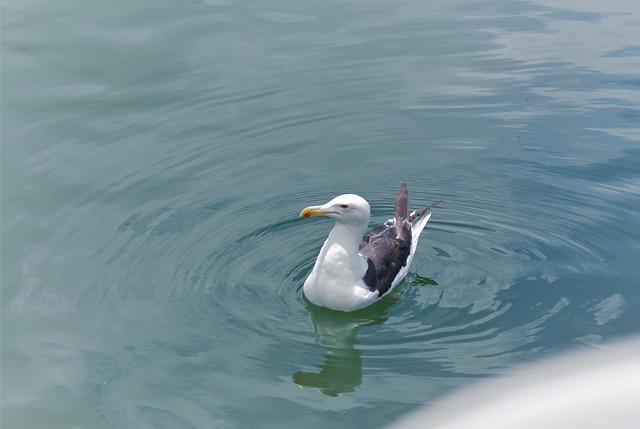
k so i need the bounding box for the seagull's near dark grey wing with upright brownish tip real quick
[360,182,411,296]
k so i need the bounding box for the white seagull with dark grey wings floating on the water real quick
[300,181,442,312]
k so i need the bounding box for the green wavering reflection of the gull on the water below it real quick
[293,301,392,396]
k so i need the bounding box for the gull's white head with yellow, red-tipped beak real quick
[300,194,371,226]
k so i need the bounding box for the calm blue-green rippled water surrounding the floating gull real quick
[2,0,640,428]
